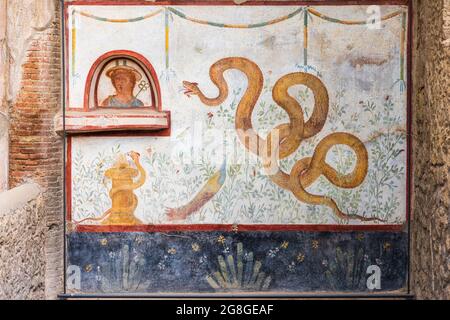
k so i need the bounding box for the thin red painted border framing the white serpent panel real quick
[64,0,413,232]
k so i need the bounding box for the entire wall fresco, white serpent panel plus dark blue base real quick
[66,4,408,294]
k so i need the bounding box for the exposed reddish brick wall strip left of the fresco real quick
[8,1,63,298]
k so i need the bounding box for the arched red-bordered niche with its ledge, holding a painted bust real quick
[56,50,170,134]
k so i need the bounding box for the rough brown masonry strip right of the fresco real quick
[411,0,450,299]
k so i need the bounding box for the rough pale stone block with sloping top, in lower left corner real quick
[0,184,45,300]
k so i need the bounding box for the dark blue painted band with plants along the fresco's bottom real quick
[68,231,407,295]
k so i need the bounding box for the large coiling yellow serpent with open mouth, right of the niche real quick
[183,57,383,222]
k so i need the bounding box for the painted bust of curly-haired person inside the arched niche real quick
[101,60,144,108]
